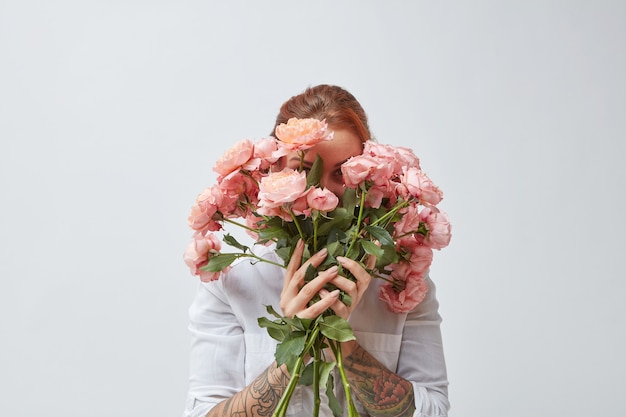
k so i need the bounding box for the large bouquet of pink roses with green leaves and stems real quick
[184,119,451,416]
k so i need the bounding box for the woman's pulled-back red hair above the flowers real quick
[272,84,372,142]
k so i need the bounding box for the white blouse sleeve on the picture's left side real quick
[184,280,244,417]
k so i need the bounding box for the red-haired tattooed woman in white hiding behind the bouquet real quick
[185,85,449,417]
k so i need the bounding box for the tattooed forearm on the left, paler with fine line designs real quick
[206,364,289,417]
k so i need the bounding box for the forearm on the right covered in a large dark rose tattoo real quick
[342,342,415,417]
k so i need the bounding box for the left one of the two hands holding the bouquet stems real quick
[280,240,343,319]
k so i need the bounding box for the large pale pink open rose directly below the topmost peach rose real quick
[259,168,306,213]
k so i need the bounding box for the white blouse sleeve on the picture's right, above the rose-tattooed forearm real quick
[397,278,450,417]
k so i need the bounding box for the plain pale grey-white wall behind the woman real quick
[0,0,626,417]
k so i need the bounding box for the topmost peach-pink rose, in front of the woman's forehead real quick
[275,117,333,151]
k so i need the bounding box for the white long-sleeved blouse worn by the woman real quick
[184,247,449,417]
